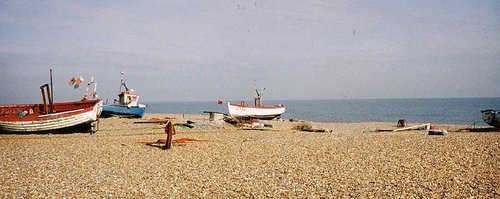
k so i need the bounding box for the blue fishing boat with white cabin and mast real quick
[101,72,146,118]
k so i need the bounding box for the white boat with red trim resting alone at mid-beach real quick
[227,88,286,120]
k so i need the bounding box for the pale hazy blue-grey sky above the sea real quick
[0,0,500,104]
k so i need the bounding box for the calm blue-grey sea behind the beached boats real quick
[145,98,500,125]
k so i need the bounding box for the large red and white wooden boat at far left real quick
[0,71,102,133]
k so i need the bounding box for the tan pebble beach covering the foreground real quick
[0,114,500,198]
